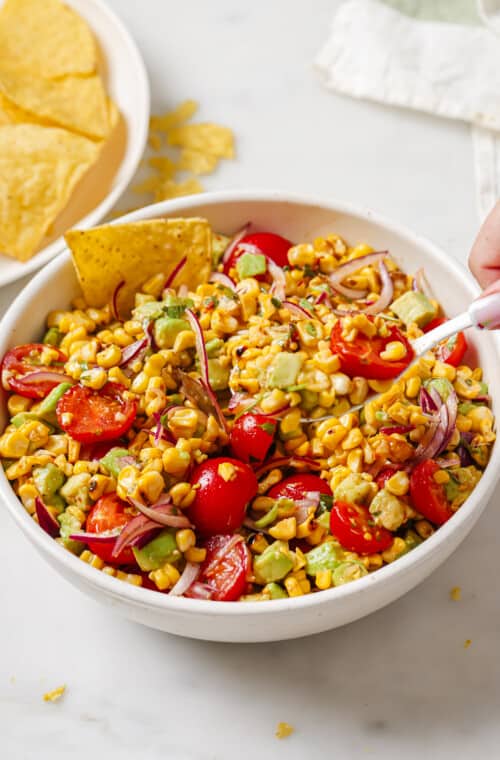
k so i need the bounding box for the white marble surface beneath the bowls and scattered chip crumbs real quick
[0,0,500,760]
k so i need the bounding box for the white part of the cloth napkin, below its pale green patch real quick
[315,0,500,217]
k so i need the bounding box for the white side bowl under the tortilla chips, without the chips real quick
[0,0,150,287]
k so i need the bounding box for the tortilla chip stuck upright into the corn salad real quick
[65,219,212,315]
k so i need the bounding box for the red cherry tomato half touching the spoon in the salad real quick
[330,317,413,380]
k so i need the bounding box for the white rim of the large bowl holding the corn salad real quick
[0,189,500,618]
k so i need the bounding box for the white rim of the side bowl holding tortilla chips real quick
[0,0,151,287]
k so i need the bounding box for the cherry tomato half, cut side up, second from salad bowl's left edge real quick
[56,383,137,443]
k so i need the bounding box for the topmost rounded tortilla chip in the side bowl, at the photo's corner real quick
[0,0,97,79]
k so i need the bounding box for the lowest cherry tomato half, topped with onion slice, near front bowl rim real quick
[186,536,250,602]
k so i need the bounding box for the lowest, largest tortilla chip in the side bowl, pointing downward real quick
[0,124,100,261]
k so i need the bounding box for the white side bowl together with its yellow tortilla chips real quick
[0,0,150,285]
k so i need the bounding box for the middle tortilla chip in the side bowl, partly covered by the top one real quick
[0,64,110,140]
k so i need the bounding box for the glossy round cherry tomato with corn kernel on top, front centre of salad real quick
[189,457,257,536]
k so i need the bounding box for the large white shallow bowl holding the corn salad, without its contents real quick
[0,191,500,642]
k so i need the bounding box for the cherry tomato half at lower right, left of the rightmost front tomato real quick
[330,501,394,554]
